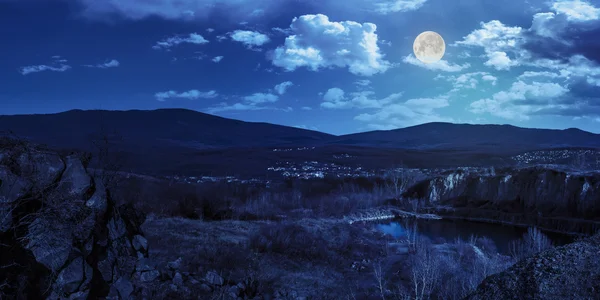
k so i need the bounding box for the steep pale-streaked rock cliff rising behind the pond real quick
[405,167,600,233]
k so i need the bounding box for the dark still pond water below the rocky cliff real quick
[377,219,573,254]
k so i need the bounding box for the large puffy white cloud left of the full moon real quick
[272,14,390,76]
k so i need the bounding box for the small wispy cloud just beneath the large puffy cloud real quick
[321,88,402,109]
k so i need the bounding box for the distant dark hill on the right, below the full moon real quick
[332,122,600,152]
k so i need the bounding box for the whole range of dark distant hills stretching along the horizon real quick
[0,109,600,174]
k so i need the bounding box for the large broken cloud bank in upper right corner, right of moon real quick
[454,0,600,76]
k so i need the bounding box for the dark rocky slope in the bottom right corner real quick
[467,235,600,300]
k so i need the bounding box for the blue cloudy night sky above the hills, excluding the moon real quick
[0,0,600,134]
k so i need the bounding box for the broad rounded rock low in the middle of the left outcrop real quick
[25,217,73,272]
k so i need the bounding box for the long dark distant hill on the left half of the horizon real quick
[0,109,333,150]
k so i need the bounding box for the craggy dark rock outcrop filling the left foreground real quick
[0,140,152,299]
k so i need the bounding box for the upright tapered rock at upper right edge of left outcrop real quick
[59,156,92,197]
